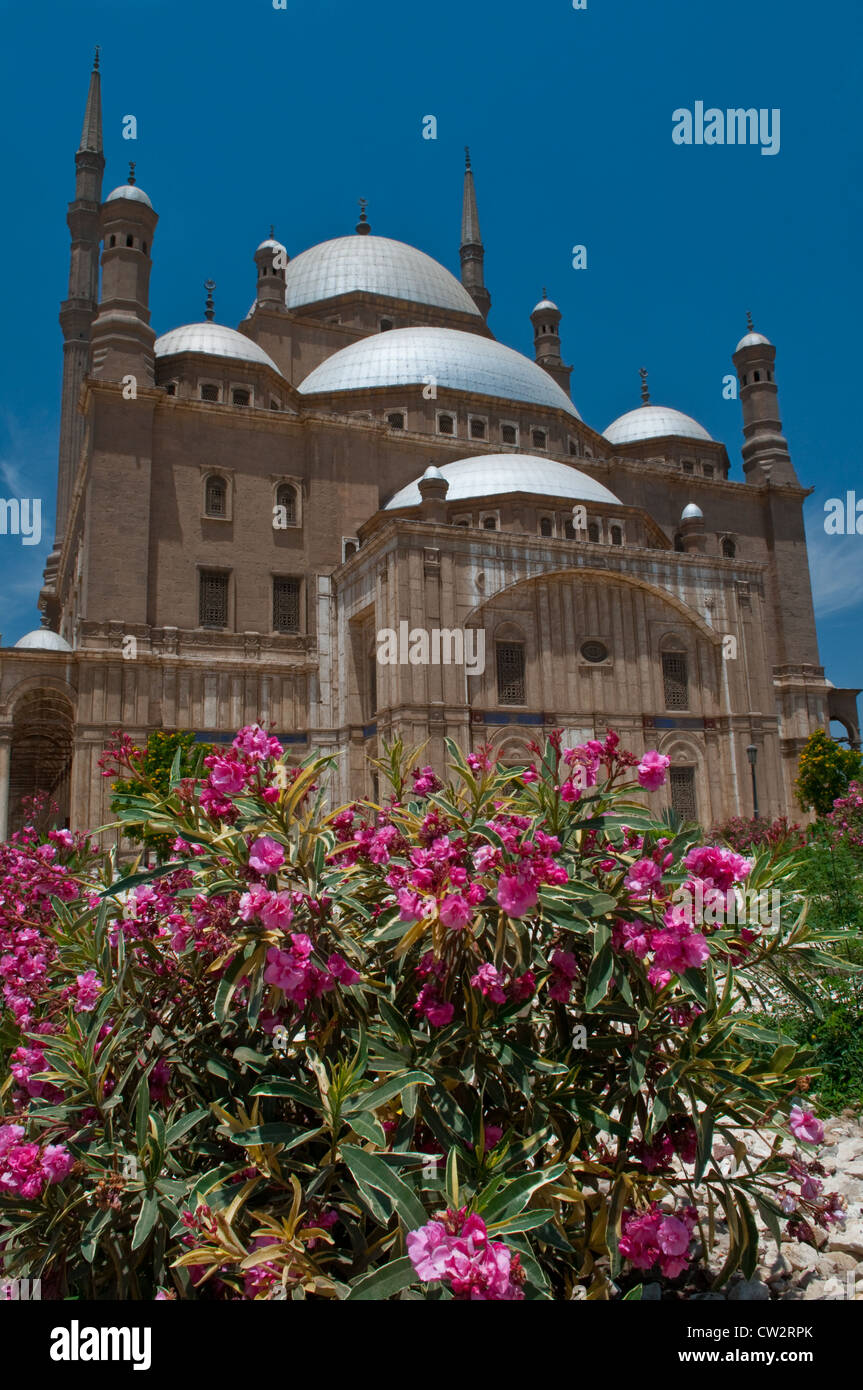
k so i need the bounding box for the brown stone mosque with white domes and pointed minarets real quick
[0,61,859,835]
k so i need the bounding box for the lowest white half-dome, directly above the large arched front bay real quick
[384,453,621,512]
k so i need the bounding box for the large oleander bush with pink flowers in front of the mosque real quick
[0,727,842,1300]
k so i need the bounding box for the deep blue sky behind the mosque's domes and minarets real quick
[0,0,863,706]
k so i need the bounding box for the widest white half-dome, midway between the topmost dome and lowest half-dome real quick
[299,328,581,420]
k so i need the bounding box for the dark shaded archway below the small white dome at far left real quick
[8,689,74,834]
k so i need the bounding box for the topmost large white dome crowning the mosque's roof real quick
[285,236,482,318]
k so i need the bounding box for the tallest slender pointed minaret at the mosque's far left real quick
[42,49,104,617]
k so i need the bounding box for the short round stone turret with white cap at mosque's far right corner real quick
[734,314,798,485]
